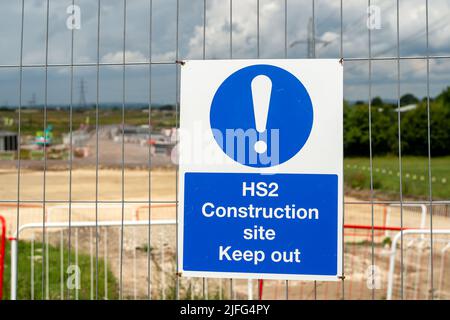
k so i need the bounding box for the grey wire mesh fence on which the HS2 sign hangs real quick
[0,0,450,300]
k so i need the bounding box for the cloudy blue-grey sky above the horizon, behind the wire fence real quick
[0,0,450,106]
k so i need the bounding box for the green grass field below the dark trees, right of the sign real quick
[344,156,450,200]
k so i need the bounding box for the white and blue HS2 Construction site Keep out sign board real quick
[178,59,343,280]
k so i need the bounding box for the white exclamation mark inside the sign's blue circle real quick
[252,75,272,153]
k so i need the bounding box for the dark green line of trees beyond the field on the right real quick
[344,87,450,156]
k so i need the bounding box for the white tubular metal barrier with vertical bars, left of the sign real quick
[6,220,239,300]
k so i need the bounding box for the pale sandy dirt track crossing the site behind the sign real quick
[0,169,450,235]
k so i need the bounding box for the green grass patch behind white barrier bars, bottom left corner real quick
[3,241,118,300]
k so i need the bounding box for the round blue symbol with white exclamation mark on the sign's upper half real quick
[210,65,313,168]
